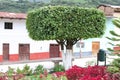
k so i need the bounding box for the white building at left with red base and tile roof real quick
[0,12,59,61]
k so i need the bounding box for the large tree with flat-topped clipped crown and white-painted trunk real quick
[26,6,105,70]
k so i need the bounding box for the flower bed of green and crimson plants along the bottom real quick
[0,65,120,80]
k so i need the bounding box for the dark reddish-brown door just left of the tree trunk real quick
[50,44,60,58]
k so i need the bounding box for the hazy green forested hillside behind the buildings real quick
[0,0,120,13]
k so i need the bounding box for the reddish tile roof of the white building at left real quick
[0,12,27,19]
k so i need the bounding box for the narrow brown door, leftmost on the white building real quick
[3,43,9,61]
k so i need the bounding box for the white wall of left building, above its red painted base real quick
[0,19,56,55]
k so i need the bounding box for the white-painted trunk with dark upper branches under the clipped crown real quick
[56,40,73,70]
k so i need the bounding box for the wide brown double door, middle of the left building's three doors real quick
[19,44,30,60]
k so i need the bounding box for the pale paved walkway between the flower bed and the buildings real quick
[0,56,117,72]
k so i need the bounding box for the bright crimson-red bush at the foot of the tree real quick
[66,65,108,80]
